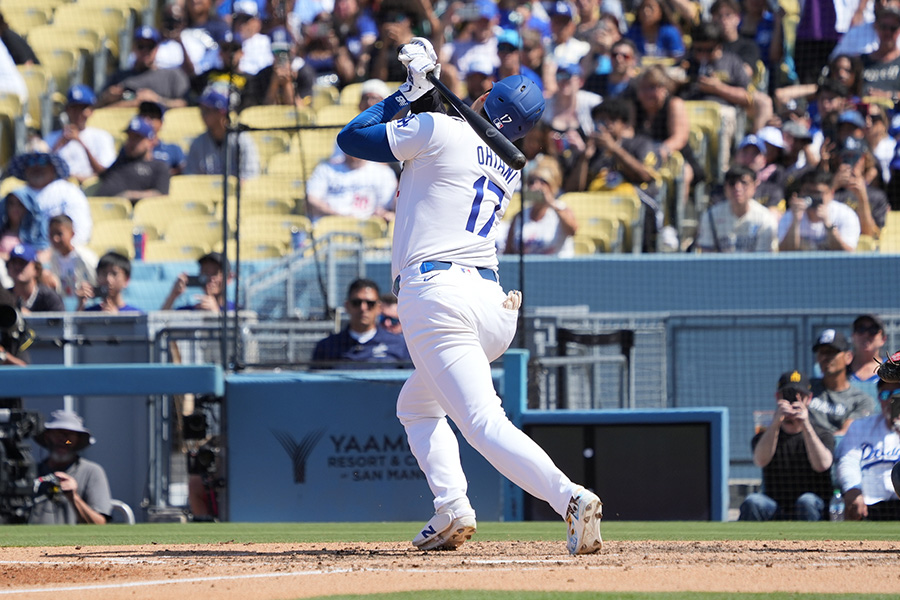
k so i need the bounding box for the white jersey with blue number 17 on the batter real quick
[387,113,520,277]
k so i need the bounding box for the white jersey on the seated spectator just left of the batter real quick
[306,161,397,219]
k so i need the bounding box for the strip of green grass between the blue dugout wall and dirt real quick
[0,521,900,547]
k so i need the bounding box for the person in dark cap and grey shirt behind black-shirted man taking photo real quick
[809,329,877,435]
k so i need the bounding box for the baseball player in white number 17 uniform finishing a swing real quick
[337,38,602,554]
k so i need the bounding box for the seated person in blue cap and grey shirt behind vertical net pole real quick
[184,89,259,179]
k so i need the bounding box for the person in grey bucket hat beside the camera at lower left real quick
[28,410,112,525]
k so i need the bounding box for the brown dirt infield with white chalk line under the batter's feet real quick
[0,541,900,600]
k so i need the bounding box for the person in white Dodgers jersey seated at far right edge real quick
[835,368,900,521]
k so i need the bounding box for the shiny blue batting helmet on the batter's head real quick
[484,75,544,142]
